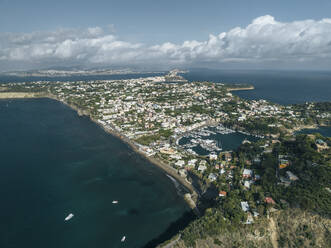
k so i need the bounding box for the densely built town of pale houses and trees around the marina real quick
[2,74,331,235]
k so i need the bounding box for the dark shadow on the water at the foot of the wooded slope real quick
[141,211,197,248]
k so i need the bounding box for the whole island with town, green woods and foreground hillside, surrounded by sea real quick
[0,74,331,248]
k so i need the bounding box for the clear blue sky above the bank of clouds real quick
[0,0,331,43]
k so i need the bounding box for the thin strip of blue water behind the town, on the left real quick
[0,73,164,83]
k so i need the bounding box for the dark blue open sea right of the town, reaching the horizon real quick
[184,69,331,104]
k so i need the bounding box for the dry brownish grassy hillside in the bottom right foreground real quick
[159,209,331,248]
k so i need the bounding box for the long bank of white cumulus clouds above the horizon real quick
[0,15,331,69]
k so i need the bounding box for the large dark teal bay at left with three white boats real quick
[0,99,187,248]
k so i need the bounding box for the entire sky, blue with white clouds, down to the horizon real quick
[0,0,331,71]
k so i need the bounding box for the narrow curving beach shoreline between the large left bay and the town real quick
[0,92,199,210]
